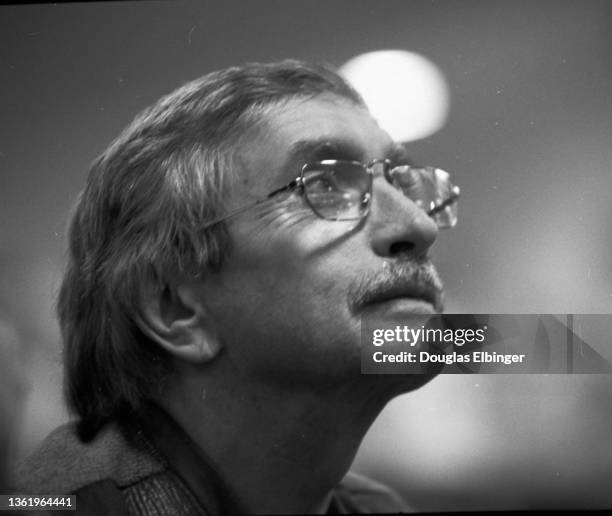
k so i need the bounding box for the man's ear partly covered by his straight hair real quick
[137,282,221,364]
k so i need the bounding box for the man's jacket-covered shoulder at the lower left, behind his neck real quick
[17,423,165,493]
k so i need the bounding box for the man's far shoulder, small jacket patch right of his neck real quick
[334,471,414,514]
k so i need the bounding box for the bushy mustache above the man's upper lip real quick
[348,258,444,312]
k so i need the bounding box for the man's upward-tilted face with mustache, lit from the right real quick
[201,92,441,392]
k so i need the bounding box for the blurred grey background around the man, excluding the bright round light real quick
[0,0,612,511]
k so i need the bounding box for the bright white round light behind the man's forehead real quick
[340,50,450,142]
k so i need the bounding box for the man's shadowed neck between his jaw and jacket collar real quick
[162,368,389,514]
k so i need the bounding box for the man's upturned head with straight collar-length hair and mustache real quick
[59,61,448,440]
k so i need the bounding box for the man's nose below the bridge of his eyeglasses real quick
[368,177,438,258]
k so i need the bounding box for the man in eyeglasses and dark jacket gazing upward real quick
[16,61,460,514]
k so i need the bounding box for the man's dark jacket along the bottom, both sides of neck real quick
[18,412,408,516]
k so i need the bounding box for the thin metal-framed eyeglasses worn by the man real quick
[201,159,460,229]
